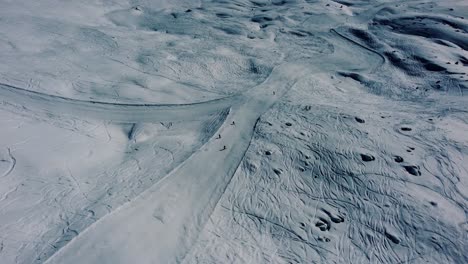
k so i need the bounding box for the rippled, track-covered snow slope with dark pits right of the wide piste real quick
[185,74,468,263]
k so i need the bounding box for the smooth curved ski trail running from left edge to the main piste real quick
[0,83,242,123]
